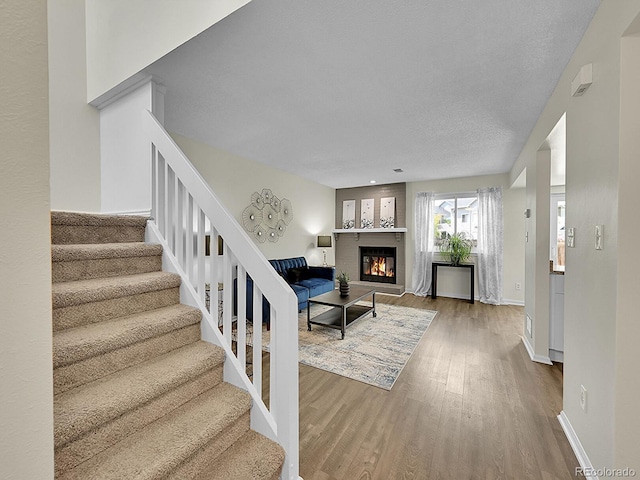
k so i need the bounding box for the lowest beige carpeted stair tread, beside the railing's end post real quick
[193,430,284,480]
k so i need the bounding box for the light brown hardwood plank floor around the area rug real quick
[288,295,578,480]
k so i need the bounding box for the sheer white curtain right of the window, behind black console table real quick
[478,187,503,305]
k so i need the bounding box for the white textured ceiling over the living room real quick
[146,0,600,188]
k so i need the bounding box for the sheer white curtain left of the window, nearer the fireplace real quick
[413,192,434,297]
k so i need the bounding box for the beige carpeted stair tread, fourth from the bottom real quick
[53,304,202,368]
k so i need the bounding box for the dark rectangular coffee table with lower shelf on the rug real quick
[307,286,376,340]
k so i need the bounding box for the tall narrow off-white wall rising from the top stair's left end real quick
[47,0,100,212]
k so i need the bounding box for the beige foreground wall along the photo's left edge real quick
[0,0,53,480]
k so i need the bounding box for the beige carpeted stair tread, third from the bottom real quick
[54,341,224,447]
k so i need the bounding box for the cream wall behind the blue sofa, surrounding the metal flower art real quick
[172,134,335,265]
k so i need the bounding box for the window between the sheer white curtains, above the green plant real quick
[433,193,478,246]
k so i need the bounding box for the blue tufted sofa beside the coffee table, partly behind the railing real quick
[234,257,336,327]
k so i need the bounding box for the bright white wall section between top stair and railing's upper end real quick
[100,82,154,213]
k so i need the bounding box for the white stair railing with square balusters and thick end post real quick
[144,111,299,480]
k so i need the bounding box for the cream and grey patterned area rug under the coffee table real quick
[262,303,438,390]
